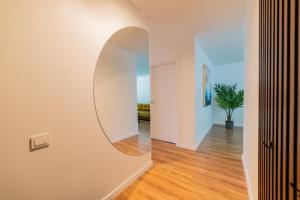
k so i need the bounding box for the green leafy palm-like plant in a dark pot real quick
[214,84,244,129]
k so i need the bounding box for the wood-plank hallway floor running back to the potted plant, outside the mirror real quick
[115,126,248,200]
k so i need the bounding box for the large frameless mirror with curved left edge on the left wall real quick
[94,27,151,156]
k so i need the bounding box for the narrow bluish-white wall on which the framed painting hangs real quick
[194,38,216,146]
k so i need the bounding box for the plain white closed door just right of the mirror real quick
[151,64,177,143]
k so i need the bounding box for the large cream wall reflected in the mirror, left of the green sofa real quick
[94,44,138,142]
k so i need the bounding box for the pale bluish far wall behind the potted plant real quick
[213,63,245,126]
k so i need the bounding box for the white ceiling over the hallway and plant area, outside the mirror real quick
[129,0,246,65]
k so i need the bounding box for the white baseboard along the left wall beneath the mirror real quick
[102,160,153,200]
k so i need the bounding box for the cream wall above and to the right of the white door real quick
[150,35,196,149]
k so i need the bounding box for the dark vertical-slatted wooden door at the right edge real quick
[259,0,300,200]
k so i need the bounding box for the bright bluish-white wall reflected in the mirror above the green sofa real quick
[136,75,151,103]
